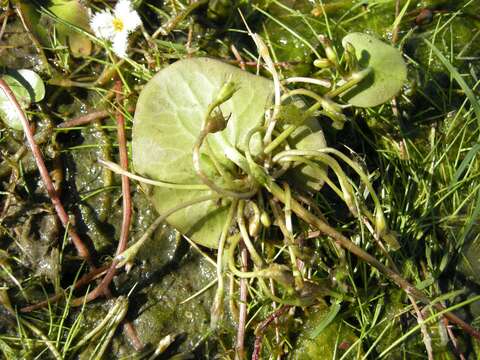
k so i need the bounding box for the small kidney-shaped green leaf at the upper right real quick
[342,33,407,107]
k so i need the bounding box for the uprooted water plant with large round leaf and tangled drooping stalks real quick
[111,34,416,323]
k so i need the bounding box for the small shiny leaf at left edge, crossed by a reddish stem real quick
[0,69,45,130]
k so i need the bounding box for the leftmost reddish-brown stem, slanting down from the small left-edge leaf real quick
[0,79,93,267]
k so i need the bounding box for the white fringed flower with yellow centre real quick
[90,0,142,58]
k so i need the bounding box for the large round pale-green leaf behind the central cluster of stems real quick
[133,58,323,248]
